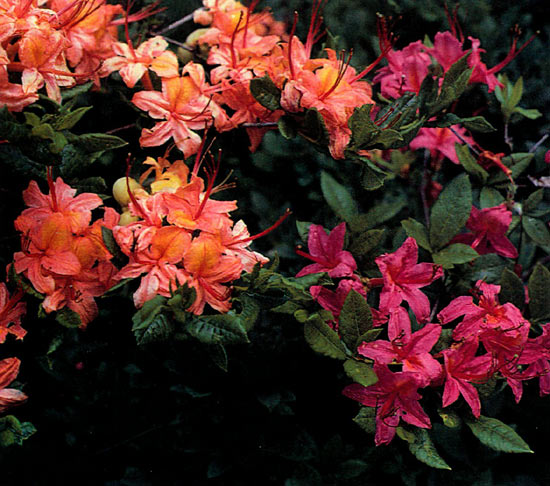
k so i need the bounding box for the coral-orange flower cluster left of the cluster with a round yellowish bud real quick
[14,172,119,326]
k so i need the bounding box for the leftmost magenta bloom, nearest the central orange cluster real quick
[296,223,357,277]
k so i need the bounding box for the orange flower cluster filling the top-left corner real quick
[0,0,162,111]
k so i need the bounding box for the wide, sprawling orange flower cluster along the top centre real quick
[101,0,391,159]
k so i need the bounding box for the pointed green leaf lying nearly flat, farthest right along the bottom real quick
[466,415,533,453]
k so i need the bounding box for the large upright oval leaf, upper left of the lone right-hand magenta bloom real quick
[430,174,472,250]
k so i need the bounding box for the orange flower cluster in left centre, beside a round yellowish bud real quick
[113,158,274,314]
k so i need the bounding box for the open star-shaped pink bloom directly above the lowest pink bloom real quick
[357,307,441,381]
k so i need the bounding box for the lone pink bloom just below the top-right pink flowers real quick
[409,125,475,165]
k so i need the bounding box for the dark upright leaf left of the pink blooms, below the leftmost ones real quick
[338,289,372,352]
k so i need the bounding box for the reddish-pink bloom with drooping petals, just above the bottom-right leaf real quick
[443,338,492,418]
